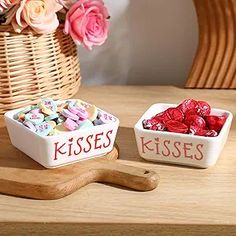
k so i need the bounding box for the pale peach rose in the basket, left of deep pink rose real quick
[12,0,62,34]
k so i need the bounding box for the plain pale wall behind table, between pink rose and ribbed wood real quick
[80,0,198,86]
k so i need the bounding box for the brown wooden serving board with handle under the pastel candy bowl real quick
[0,128,159,199]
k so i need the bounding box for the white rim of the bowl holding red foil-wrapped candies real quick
[134,103,233,140]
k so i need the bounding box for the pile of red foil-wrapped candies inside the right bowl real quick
[143,99,227,137]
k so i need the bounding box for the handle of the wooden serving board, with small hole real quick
[90,160,159,191]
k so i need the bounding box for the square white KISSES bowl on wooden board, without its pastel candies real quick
[5,99,119,168]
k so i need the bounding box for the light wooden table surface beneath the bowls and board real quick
[0,86,236,235]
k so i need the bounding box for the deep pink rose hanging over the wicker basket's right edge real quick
[65,0,109,50]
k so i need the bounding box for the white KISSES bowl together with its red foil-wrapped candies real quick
[134,99,233,168]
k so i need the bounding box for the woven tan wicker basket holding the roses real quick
[0,26,81,119]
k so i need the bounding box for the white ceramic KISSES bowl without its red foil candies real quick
[135,103,233,168]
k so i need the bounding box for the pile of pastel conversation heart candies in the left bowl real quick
[14,98,115,136]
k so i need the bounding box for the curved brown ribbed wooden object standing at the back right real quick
[186,0,236,89]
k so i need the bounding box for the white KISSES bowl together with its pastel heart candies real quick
[5,98,119,168]
